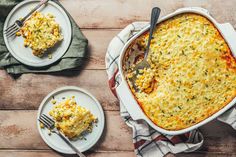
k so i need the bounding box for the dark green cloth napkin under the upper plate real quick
[0,0,88,74]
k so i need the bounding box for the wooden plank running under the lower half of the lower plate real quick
[0,110,236,154]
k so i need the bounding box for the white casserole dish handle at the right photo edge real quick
[218,23,236,57]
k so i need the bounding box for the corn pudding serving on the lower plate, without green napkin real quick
[49,98,97,139]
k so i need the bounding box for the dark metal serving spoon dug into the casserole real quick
[130,7,161,91]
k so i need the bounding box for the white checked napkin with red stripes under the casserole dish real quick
[106,22,236,157]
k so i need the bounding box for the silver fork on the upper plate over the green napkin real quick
[4,0,49,38]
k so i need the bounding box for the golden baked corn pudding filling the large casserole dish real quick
[123,13,236,130]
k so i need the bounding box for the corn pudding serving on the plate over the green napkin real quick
[16,11,63,57]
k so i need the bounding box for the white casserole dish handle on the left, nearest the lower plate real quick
[116,77,144,120]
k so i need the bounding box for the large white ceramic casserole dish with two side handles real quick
[116,7,236,135]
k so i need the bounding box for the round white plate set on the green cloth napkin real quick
[3,0,72,67]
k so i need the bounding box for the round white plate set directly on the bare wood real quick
[37,86,105,154]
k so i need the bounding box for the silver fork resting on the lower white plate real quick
[38,114,86,157]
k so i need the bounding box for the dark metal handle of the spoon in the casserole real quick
[144,7,161,59]
